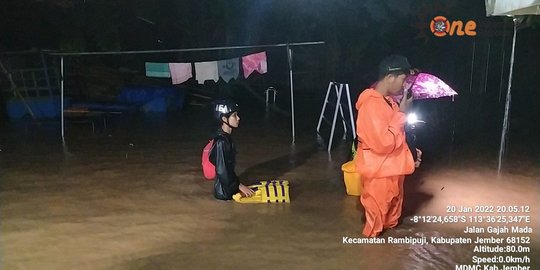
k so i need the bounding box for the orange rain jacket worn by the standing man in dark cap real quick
[356,88,414,178]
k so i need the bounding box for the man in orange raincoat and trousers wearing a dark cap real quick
[356,55,415,237]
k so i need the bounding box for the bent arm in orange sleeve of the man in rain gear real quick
[358,99,406,154]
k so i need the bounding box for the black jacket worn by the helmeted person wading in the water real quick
[210,130,240,200]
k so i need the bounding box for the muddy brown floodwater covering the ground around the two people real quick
[0,106,540,270]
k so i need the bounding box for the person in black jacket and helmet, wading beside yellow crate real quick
[210,100,255,200]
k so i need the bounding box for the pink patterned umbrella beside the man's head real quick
[403,72,457,99]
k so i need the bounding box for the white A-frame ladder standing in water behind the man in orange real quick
[317,82,356,153]
